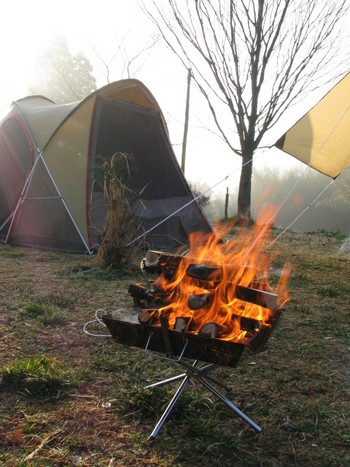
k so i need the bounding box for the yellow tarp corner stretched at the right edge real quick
[275,73,350,178]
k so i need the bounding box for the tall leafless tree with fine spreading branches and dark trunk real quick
[139,0,348,218]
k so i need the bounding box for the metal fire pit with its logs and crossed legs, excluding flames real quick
[102,252,288,439]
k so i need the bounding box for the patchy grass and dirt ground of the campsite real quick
[0,232,350,466]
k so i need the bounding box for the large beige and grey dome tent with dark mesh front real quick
[0,79,212,252]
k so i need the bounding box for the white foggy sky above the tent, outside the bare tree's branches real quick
[0,0,298,191]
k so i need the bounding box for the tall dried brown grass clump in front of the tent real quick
[97,152,143,269]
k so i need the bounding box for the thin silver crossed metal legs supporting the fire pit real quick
[145,326,263,440]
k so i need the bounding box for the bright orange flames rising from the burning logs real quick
[156,211,292,342]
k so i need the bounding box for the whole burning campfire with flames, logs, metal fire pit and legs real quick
[103,214,291,439]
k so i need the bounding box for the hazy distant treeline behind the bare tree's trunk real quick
[202,169,350,234]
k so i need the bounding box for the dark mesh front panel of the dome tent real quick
[90,99,209,247]
